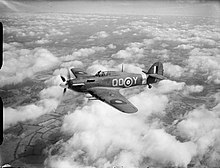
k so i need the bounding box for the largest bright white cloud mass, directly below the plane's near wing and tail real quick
[45,81,196,168]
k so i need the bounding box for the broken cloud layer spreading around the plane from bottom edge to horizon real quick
[0,10,220,168]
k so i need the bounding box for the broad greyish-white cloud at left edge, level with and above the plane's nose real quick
[0,44,59,87]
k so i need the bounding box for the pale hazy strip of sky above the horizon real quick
[0,0,220,17]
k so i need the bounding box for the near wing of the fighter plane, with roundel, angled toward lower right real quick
[88,87,138,113]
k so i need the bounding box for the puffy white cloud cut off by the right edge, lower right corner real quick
[177,100,220,167]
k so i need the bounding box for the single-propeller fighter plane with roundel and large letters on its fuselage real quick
[60,62,165,113]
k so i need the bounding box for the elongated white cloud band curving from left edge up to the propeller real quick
[3,86,62,130]
